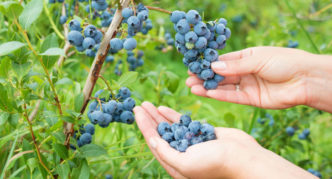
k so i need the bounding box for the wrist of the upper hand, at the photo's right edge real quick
[305,55,332,112]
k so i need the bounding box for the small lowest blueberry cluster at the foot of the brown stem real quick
[70,124,95,150]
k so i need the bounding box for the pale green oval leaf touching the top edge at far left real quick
[19,0,43,29]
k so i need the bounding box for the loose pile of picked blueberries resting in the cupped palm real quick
[157,115,216,152]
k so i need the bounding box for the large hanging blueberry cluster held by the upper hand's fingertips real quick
[170,10,231,89]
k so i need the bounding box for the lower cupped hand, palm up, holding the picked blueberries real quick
[134,102,315,179]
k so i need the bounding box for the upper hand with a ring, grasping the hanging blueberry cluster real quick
[186,47,332,112]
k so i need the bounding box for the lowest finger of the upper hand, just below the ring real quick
[206,89,250,105]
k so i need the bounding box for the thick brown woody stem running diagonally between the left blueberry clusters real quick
[65,0,130,147]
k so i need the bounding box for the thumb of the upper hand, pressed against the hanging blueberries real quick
[211,56,260,76]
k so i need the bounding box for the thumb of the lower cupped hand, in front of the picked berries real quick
[149,137,183,171]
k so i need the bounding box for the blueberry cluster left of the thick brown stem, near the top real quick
[67,19,103,57]
